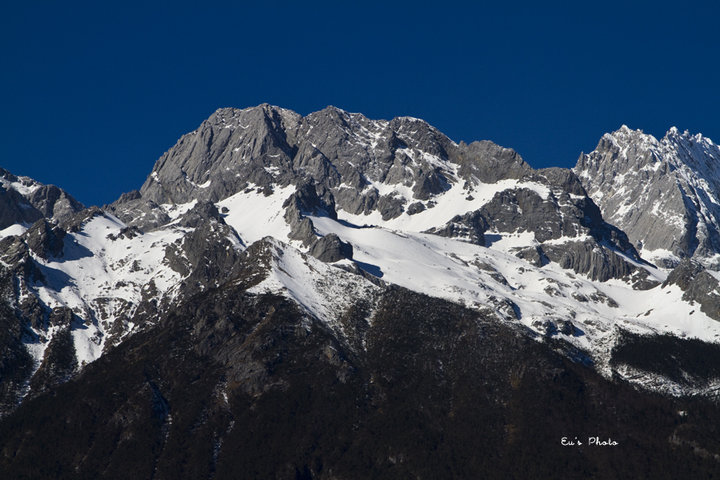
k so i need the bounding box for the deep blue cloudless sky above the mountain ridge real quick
[0,1,720,205]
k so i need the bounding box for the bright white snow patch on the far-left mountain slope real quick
[31,214,185,363]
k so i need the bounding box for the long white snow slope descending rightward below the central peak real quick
[215,186,720,376]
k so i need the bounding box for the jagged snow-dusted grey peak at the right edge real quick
[574,126,720,266]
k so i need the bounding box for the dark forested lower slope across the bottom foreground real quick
[0,285,720,480]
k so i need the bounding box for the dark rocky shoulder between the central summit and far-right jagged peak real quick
[429,168,643,281]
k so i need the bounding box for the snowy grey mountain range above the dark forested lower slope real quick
[0,105,720,476]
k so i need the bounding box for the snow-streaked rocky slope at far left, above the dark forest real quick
[0,199,244,412]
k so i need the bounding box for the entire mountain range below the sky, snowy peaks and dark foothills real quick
[0,104,720,480]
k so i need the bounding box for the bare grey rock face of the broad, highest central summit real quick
[118,104,532,223]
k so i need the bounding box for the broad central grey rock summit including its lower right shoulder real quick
[112,104,642,286]
